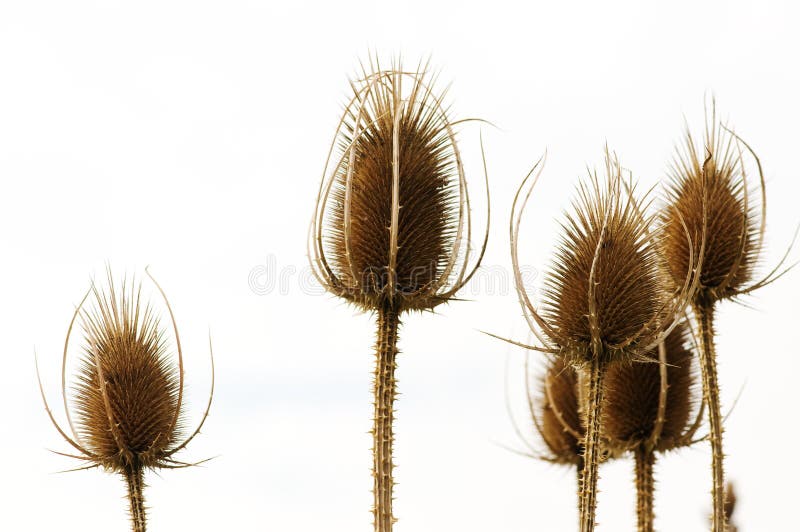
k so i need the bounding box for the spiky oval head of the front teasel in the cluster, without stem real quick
[541,152,676,364]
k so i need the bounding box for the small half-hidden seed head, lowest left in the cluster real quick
[538,358,585,464]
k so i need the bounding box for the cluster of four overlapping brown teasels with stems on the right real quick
[510,107,791,532]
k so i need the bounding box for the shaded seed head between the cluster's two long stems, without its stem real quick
[602,322,695,452]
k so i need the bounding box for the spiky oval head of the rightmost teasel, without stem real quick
[662,115,761,302]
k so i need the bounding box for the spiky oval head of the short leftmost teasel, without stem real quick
[74,277,181,472]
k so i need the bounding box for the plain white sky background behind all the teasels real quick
[0,0,800,532]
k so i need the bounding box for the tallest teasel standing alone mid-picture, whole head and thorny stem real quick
[309,60,489,532]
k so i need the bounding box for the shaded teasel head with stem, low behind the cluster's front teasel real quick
[602,322,703,532]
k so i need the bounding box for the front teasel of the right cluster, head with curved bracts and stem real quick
[509,153,694,532]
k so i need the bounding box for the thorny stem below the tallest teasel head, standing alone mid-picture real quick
[372,302,400,532]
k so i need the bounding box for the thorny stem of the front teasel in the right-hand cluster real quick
[578,353,606,532]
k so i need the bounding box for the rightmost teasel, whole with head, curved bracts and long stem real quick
[661,104,792,532]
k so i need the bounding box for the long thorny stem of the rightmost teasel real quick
[694,301,725,532]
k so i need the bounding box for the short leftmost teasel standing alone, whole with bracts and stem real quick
[37,271,214,532]
